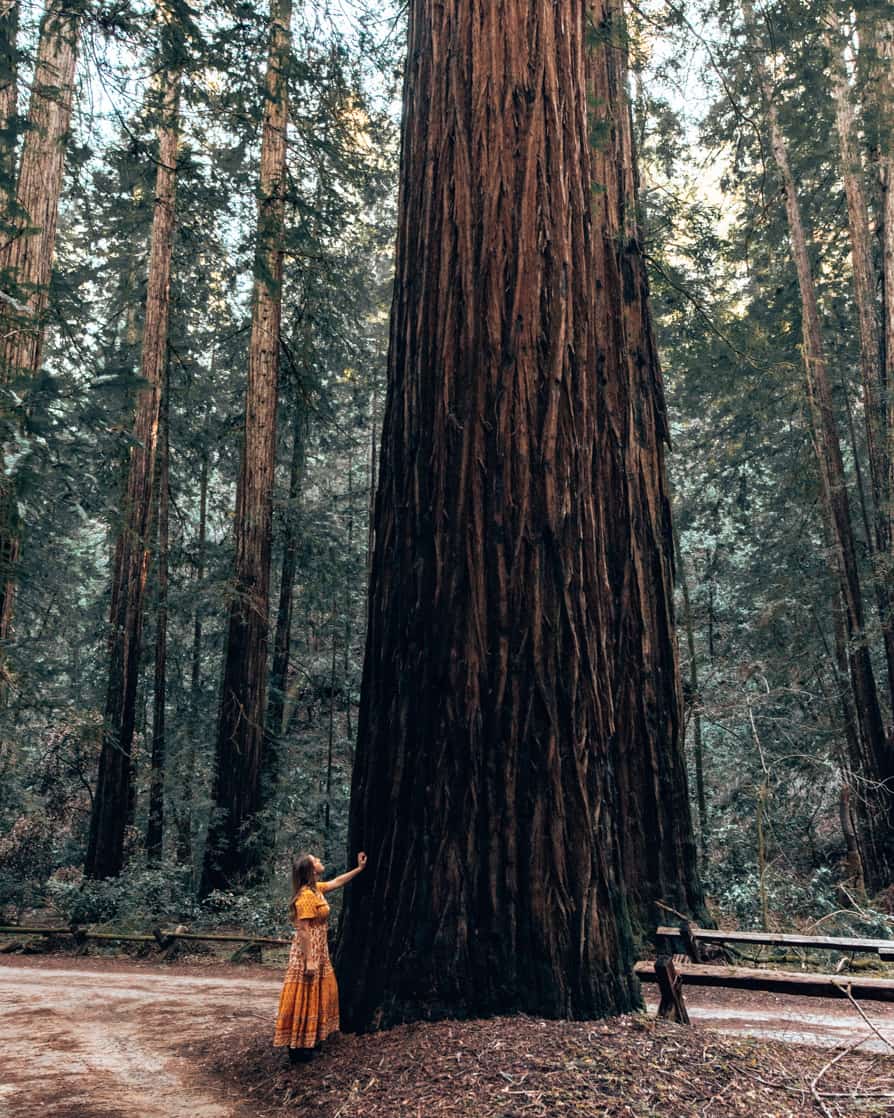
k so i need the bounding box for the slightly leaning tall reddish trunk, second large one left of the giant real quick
[85,64,180,878]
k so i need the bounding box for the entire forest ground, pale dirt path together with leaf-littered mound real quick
[0,955,894,1118]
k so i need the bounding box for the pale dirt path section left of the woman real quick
[0,959,279,1118]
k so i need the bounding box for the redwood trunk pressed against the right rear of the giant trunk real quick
[590,0,704,935]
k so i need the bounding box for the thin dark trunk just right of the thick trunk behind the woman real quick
[261,404,306,806]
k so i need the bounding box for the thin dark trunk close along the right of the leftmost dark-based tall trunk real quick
[146,370,171,862]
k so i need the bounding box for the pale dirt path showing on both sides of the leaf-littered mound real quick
[0,956,894,1118]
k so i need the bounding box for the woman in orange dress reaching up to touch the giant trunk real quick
[273,854,367,1063]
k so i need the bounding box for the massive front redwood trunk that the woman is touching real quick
[339,0,638,1030]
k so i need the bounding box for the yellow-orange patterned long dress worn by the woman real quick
[273,881,339,1049]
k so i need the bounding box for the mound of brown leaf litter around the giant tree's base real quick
[191,1017,894,1118]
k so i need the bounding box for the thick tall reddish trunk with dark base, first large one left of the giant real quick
[201,0,292,894]
